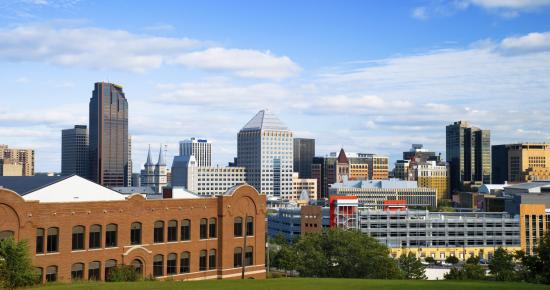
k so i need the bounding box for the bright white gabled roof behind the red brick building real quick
[23,175,125,202]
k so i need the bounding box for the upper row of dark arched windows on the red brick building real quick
[36,216,254,254]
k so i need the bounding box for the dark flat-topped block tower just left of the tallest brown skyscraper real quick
[61,125,90,178]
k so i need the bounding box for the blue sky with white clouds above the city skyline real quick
[0,0,550,172]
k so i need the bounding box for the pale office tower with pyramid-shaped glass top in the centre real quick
[237,110,294,197]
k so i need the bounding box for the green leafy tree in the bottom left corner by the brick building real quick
[0,238,38,289]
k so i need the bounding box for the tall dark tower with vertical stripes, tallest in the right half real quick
[446,121,491,190]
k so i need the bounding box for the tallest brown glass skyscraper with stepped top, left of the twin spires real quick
[89,82,131,187]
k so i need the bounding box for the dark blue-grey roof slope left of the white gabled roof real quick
[0,175,69,196]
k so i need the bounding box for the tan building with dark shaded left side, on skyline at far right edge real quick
[507,143,550,182]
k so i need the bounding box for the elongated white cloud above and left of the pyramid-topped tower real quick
[175,47,300,79]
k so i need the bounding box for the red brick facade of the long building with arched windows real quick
[0,185,266,281]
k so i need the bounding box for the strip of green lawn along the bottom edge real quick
[38,278,550,290]
